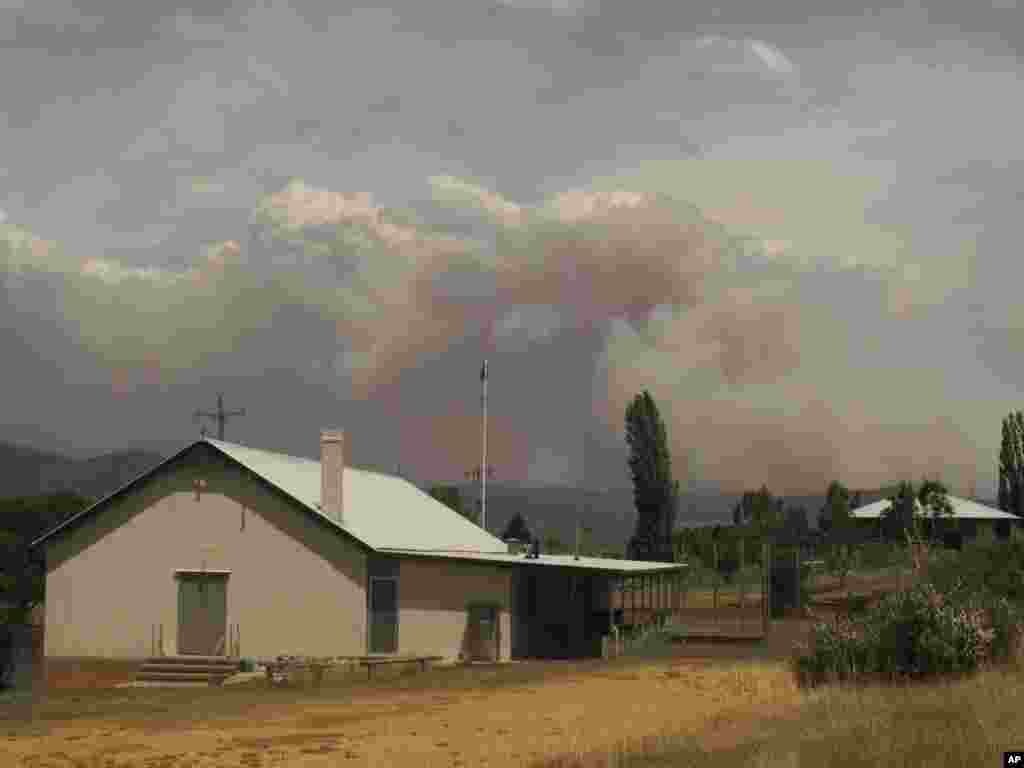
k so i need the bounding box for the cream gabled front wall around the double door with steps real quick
[45,453,368,657]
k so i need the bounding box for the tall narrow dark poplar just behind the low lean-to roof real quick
[626,390,680,562]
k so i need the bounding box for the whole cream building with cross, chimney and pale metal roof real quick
[32,432,684,675]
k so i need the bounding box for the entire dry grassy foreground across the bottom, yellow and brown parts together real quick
[6,657,1024,768]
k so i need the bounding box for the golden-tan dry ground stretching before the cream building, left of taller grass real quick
[0,660,799,768]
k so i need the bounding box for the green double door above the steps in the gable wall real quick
[178,573,227,656]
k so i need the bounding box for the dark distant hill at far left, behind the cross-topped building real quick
[0,442,166,499]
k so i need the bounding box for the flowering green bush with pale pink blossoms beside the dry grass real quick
[795,584,1022,685]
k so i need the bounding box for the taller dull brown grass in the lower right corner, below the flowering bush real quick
[534,667,1024,768]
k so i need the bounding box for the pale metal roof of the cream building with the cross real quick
[32,438,684,572]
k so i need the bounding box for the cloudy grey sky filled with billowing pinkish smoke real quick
[0,0,1024,496]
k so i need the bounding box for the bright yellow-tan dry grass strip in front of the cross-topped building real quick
[0,659,802,768]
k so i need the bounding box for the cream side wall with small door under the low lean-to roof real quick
[398,558,512,660]
